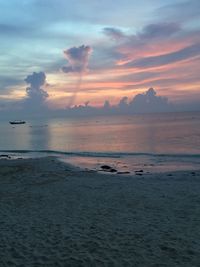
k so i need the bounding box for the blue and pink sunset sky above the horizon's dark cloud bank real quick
[0,0,200,113]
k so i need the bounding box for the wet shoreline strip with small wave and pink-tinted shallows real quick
[0,150,200,175]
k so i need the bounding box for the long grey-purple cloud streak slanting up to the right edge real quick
[123,44,200,68]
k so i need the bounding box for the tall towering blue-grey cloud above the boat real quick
[23,72,49,109]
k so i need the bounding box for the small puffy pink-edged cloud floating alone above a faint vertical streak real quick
[62,45,92,73]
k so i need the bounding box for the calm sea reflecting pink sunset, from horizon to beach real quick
[0,113,200,173]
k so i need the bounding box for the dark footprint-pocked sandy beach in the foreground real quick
[0,157,200,267]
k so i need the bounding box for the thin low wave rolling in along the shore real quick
[0,150,200,158]
